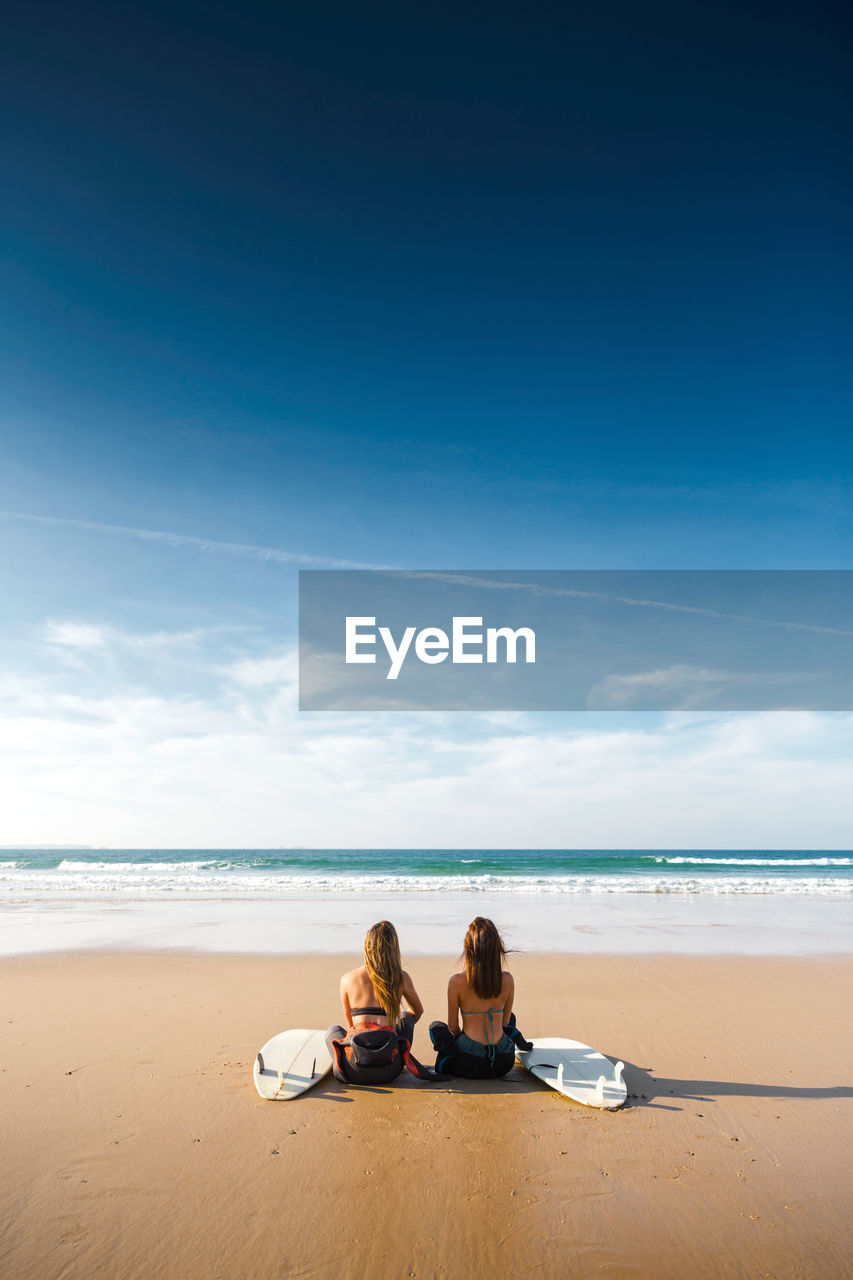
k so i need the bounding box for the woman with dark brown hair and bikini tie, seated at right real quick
[429,915,533,1079]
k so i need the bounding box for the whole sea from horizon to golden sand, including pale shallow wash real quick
[0,849,853,955]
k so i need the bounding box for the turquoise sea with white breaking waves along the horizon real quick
[0,849,853,901]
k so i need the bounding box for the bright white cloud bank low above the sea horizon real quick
[0,622,853,849]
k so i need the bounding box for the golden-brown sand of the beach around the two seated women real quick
[0,952,853,1280]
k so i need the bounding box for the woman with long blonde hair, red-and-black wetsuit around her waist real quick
[325,920,442,1084]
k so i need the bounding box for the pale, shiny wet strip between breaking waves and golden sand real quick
[0,888,850,959]
